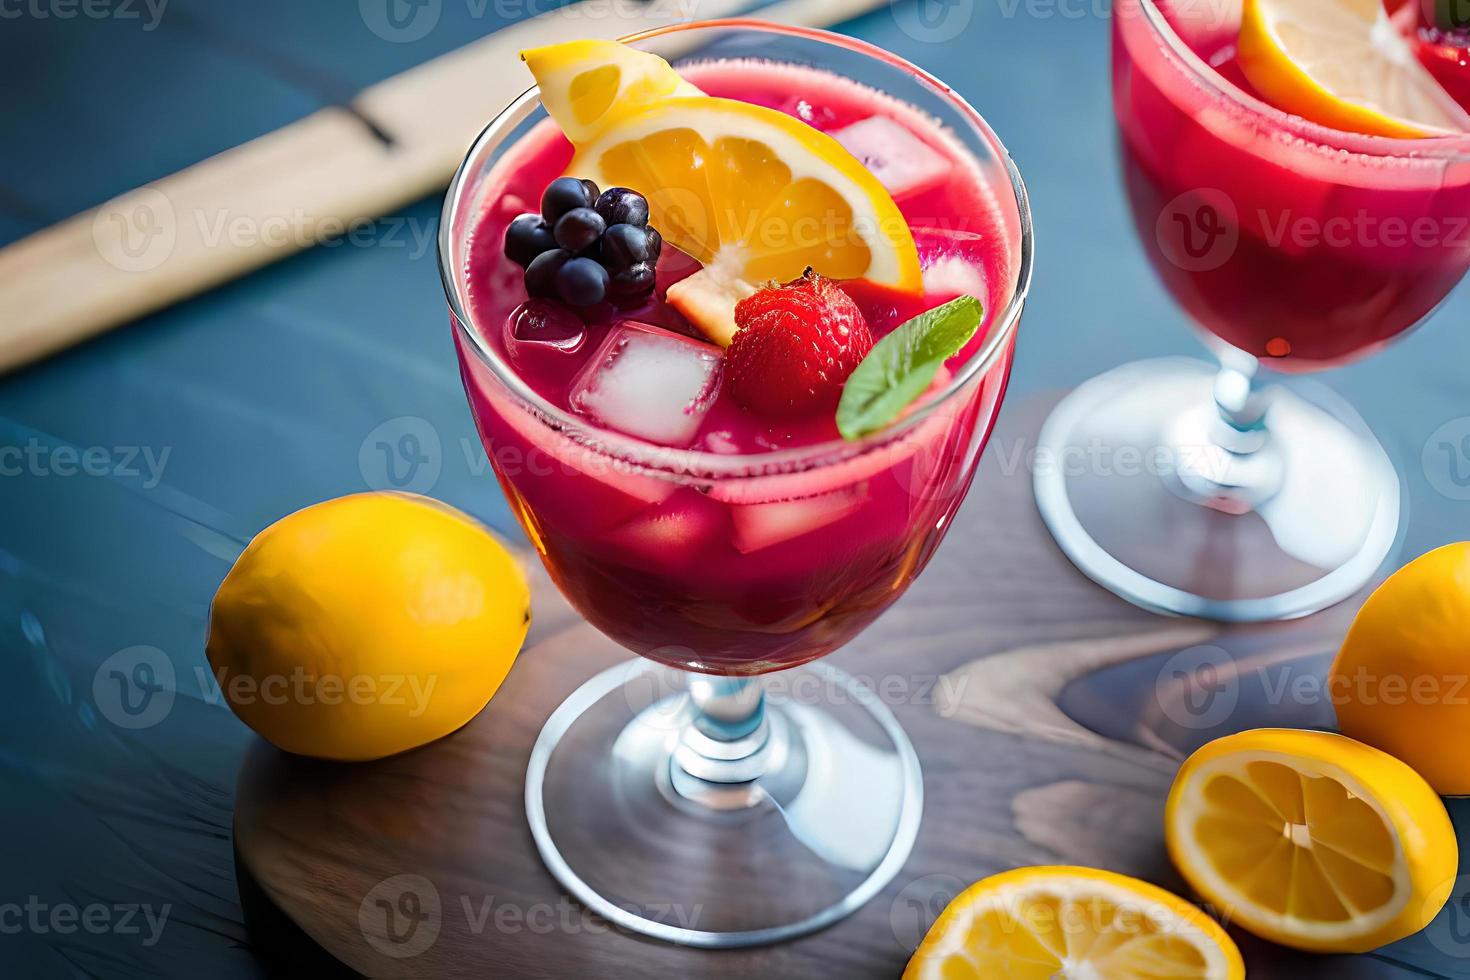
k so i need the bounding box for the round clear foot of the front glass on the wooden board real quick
[526,660,923,948]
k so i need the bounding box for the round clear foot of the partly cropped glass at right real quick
[1035,357,1399,623]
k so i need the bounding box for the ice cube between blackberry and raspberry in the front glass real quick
[570,322,722,448]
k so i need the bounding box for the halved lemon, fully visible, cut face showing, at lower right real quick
[1164,729,1458,952]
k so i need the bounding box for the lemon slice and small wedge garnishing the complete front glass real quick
[523,41,923,345]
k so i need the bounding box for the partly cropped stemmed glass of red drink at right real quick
[1035,0,1470,621]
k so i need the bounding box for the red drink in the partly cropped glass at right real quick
[1113,0,1470,372]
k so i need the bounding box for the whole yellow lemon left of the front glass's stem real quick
[206,494,531,760]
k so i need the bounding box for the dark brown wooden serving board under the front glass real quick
[235,398,1470,980]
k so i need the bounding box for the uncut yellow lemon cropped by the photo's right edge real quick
[1327,541,1470,796]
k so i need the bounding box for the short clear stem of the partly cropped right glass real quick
[1175,351,1283,514]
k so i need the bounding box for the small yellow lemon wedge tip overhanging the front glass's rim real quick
[520,41,704,143]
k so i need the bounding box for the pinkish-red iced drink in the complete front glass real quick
[459,62,1020,673]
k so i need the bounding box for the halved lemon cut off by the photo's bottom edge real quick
[904,867,1245,980]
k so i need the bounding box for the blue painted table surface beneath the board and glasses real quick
[0,0,1470,980]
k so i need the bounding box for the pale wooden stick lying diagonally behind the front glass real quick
[0,0,882,372]
